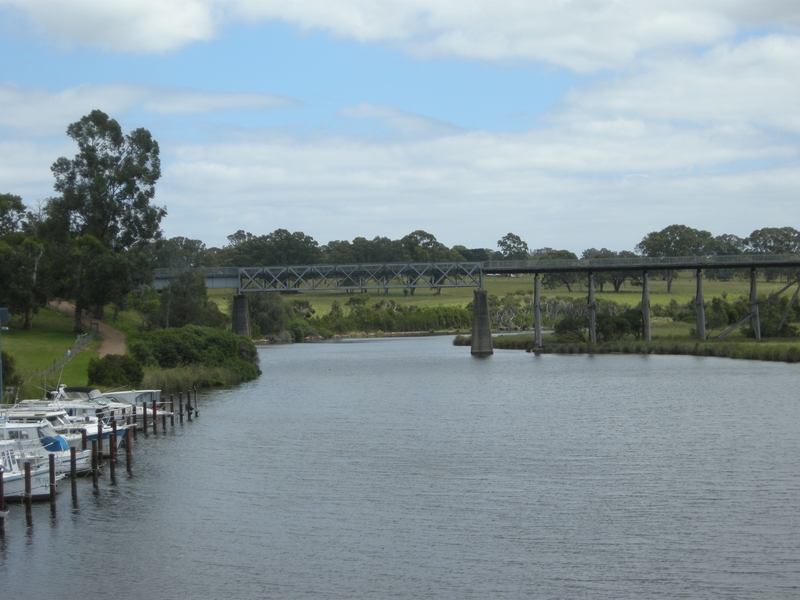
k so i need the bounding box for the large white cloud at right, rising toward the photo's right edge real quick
[557,35,800,133]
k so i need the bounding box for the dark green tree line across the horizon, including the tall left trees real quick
[0,110,800,340]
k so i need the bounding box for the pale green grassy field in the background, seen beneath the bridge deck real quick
[208,271,784,315]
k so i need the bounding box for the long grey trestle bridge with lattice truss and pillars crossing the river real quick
[154,254,800,355]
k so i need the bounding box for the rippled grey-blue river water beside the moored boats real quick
[0,338,800,599]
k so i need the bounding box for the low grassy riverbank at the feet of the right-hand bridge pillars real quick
[453,333,800,363]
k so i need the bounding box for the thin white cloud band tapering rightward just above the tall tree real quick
[0,83,299,137]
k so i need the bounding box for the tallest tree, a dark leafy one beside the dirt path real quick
[45,110,167,332]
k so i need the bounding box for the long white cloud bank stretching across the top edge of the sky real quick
[0,0,800,72]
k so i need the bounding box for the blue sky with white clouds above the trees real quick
[0,0,800,254]
